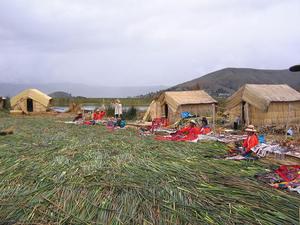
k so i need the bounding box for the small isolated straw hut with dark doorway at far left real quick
[10,89,52,114]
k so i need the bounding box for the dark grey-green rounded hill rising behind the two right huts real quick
[167,68,300,96]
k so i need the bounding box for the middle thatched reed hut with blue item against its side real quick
[144,90,217,123]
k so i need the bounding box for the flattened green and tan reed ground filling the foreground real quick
[0,116,300,225]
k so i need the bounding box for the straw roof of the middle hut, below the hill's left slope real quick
[158,90,217,110]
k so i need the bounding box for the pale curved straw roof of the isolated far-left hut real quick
[10,89,52,107]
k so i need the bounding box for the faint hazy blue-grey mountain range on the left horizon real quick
[0,83,167,98]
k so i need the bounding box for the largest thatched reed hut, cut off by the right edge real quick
[227,84,300,126]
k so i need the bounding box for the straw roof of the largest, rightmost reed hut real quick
[227,84,300,111]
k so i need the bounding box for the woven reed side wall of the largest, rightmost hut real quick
[249,102,300,126]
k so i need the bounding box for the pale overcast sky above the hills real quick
[0,0,300,86]
